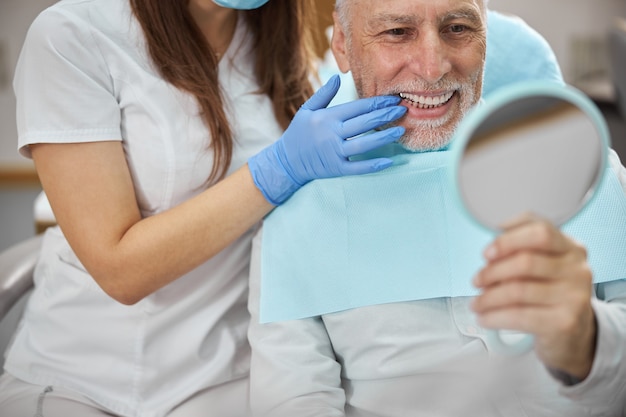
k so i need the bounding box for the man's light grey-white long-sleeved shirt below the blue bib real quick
[248,150,626,417]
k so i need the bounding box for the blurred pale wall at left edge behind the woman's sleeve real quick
[0,0,56,166]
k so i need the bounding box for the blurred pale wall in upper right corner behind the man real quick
[489,0,626,82]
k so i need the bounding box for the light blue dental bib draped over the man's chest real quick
[260,145,626,323]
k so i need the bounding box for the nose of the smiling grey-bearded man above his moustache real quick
[408,33,452,84]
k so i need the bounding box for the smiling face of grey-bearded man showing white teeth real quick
[331,0,486,151]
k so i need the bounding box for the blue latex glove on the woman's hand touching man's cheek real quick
[248,75,407,205]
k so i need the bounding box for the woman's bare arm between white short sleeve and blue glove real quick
[30,141,273,304]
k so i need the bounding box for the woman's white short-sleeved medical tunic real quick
[5,0,282,417]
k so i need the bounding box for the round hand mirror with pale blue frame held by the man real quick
[451,82,609,353]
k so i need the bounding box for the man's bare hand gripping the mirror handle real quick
[473,217,596,380]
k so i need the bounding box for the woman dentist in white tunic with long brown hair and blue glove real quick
[0,0,406,417]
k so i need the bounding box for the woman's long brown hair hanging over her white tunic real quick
[130,0,316,180]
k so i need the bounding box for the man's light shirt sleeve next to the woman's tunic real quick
[248,226,346,417]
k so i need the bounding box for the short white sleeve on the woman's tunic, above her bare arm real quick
[13,9,121,157]
